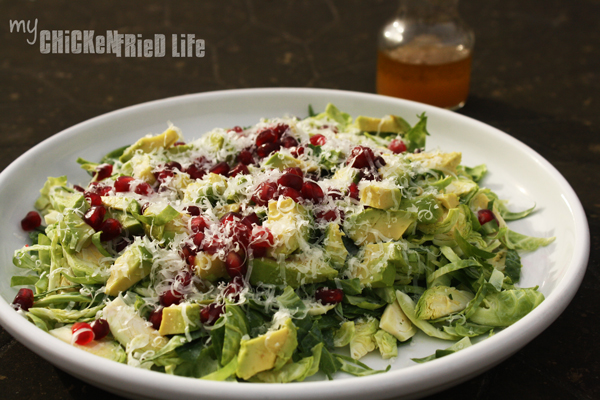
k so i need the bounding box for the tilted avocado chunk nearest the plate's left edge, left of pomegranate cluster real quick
[104,243,152,296]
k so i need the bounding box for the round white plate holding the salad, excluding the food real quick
[0,89,589,400]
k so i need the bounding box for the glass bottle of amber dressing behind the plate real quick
[377,0,475,110]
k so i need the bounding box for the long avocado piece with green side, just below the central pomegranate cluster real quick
[250,255,338,288]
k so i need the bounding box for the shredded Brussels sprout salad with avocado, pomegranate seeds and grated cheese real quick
[11,104,554,383]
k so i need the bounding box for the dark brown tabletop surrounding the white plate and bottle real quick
[0,0,600,400]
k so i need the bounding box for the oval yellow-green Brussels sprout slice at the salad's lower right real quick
[415,286,474,320]
